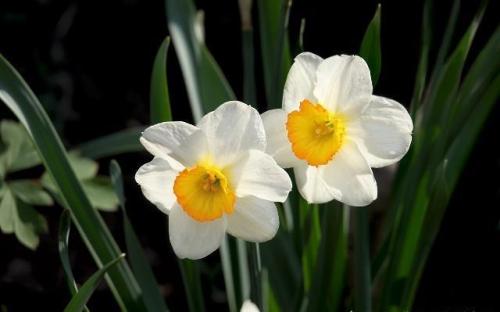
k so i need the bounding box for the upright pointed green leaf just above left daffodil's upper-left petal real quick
[149,37,172,124]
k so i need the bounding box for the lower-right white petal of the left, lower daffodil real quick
[227,196,280,242]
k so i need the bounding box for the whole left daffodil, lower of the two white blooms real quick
[135,101,292,259]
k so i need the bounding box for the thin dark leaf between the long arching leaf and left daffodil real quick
[109,160,168,312]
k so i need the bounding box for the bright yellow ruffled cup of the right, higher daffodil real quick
[286,100,346,166]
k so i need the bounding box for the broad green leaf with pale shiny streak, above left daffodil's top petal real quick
[166,0,235,121]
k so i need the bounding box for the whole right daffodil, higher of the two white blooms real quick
[262,53,413,206]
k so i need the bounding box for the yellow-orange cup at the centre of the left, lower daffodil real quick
[174,164,236,222]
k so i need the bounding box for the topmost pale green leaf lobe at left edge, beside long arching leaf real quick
[0,120,42,172]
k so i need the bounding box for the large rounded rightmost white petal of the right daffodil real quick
[350,96,413,168]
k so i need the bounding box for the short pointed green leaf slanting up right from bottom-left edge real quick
[64,254,125,312]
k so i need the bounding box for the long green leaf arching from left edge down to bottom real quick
[0,55,145,311]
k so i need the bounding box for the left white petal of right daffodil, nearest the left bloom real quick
[261,109,302,168]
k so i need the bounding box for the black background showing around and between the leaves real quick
[0,0,500,311]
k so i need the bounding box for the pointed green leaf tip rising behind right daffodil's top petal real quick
[359,4,382,86]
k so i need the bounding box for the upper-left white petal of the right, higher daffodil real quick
[283,52,323,113]
